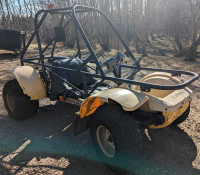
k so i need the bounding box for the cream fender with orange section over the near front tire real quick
[80,88,149,118]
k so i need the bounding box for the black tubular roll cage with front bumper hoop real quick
[20,5,199,97]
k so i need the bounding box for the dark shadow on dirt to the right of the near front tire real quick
[146,127,200,175]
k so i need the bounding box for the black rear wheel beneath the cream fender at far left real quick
[3,79,39,120]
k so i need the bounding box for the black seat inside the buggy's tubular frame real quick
[51,57,108,98]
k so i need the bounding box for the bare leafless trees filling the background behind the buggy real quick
[0,0,200,59]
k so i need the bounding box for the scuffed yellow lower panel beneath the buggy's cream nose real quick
[149,101,190,129]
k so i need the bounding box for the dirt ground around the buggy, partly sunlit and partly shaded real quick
[0,46,200,175]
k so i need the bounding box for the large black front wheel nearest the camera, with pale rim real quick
[90,104,148,174]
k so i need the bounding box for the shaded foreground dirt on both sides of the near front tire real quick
[0,103,199,175]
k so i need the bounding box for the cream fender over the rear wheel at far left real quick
[12,66,46,100]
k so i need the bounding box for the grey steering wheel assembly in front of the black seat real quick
[101,52,125,77]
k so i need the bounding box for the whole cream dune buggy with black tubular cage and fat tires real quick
[3,6,198,172]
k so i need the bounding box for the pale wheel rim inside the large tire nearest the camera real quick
[96,125,116,158]
